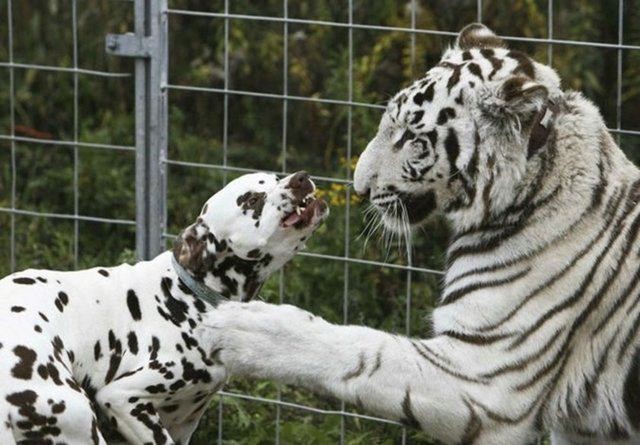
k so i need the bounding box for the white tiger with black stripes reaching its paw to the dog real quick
[201,24,640,444]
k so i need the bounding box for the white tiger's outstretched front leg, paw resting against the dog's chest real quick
[198,302,535,445]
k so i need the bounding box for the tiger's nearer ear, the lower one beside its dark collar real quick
[478,76,549,120]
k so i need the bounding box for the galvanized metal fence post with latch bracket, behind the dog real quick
[106,0,169,260]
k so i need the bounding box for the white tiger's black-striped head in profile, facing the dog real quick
[354,24,562,231]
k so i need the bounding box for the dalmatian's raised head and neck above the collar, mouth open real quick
[173,172,329,300]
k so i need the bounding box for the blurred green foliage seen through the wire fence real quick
[0,0,640,445]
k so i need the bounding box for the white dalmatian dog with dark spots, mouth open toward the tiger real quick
[0,172,328,445]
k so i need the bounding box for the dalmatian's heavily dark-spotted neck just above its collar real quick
[173,251,272,301]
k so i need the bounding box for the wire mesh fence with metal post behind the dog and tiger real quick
[0,0,640,444]
